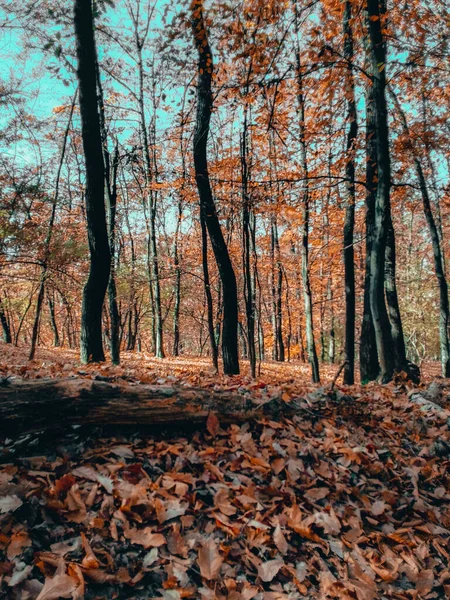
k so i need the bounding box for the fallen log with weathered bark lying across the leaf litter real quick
[0,378,286,437]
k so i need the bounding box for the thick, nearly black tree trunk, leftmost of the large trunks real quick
[74,0,111,363]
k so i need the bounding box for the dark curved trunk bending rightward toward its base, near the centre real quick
[191,0,239,375]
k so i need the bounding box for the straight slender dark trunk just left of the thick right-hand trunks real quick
[343,0,358,385]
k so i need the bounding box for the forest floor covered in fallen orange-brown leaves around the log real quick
[0,345,450,600]
